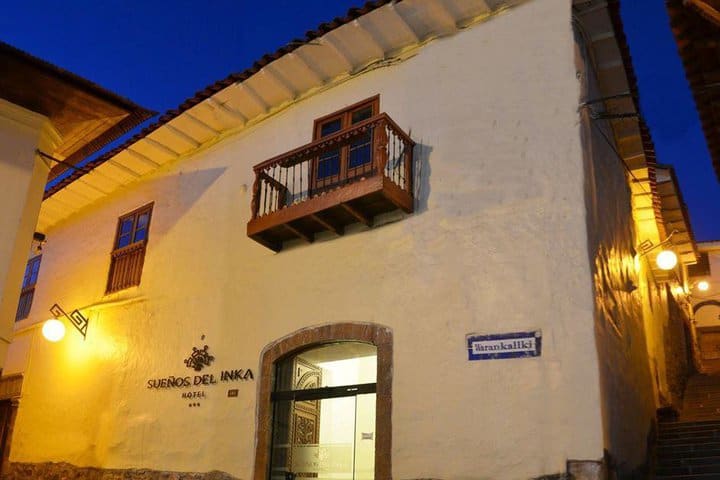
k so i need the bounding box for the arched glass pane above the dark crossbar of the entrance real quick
[275,342,377,391]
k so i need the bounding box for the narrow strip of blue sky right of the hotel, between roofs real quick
[621,0,720,241]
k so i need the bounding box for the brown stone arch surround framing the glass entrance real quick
[252,323,393,480]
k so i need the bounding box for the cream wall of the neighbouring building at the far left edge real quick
[0,99,57,369]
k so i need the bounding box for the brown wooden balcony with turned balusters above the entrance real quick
[247,113,415,252]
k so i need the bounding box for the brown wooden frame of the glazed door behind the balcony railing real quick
[310,94,380,192]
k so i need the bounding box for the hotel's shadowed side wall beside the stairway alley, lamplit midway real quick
[577,20,661,478]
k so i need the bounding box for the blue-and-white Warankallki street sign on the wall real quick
[467,330,542,360]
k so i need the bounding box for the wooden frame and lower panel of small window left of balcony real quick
[105,202,155,294]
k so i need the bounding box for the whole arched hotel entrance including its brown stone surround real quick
[253,322,393,480]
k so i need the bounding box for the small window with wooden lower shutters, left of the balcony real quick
[106,203,153,293]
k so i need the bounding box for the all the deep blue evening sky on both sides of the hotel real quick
[0,0,720,240]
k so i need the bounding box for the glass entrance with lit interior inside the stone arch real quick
[270,342,377,480]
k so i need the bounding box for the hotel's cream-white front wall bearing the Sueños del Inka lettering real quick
[5,0,603,479]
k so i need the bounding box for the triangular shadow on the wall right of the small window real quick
[152,167,229,235]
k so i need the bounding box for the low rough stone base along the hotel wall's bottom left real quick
[3,462,237,480]
